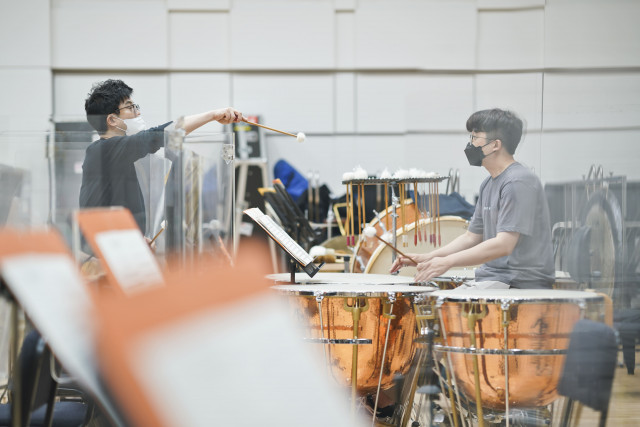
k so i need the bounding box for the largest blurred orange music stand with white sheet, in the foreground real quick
[97,246,359,427]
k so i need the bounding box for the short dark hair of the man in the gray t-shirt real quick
[467,108,522,154]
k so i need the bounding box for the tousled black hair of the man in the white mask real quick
[84,79,133,134]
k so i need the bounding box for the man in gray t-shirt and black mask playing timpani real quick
[391,109,555,289]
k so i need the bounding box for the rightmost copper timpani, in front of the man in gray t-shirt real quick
[432,289,604,416]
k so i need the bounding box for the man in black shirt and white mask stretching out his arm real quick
[80,80,244,233]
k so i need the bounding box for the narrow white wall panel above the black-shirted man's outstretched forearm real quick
[169,73,231,132]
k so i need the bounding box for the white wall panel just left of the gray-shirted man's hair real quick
[356,73,473,133]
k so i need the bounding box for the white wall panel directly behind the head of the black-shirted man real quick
[53,73,173,126]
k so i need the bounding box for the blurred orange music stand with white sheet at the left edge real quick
[0,228,124,427]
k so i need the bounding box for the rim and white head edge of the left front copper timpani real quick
[271,283,438,298]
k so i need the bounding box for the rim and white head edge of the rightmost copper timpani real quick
[431,288,604,304]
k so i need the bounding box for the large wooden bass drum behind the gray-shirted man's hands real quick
[351,216,469,277]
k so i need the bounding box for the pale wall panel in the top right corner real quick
[545,0,640,67]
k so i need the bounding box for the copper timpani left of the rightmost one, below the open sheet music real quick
[272,280,435,397]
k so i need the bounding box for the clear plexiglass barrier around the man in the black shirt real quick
[0,130,235,256]
